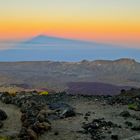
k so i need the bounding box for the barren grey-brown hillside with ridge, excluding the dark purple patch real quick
[0,59,140,94]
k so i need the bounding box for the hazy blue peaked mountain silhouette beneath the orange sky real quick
[0,35,140,61]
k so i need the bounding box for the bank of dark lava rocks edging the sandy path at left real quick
[3,93,51,140]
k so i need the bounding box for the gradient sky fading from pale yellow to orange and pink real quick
[0,0,140,47]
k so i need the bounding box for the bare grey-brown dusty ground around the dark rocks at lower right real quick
[40,99,140,140]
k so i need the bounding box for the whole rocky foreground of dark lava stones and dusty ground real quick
[0,89,140,140]
